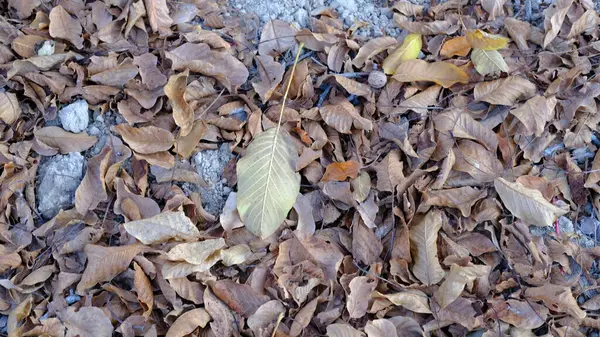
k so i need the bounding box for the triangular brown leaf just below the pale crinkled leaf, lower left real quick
[77,245,145,294]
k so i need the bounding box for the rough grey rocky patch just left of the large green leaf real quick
[194,143,233,215]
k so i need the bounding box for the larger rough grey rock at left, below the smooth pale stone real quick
[36,152,85,219]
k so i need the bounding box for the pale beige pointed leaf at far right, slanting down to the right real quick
[494,178,567,227]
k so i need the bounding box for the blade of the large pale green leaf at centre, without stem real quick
[237,127,300,238]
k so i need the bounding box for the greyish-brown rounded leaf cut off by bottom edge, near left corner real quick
[59,307,113,337]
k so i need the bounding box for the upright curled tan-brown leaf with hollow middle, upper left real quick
[164,69,194,137]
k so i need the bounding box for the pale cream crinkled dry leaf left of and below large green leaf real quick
[123,211,200,245]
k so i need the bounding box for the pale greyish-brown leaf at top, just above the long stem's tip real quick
[258,20,296,55]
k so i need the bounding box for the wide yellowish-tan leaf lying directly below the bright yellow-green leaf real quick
[393,60,469,88]
